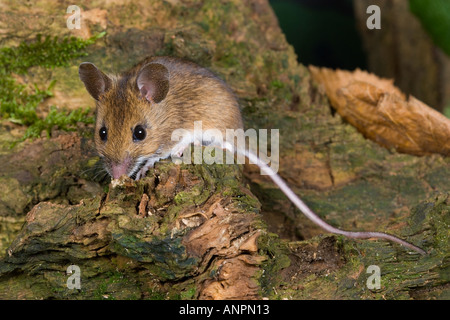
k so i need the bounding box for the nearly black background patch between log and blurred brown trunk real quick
[269,0,366,70]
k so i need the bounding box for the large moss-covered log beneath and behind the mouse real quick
[0,0,450,299]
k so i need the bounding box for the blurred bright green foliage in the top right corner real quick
[409,0,450,55]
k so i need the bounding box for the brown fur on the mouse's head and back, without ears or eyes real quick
[80,57,243,178]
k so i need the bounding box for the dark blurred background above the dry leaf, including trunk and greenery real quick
[269,0,450,118]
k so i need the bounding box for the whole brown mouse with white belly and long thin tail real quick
[79,56,426,255]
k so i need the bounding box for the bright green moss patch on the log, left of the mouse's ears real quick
[0,32,105,144]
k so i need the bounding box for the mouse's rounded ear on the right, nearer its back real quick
[136,63,169,103]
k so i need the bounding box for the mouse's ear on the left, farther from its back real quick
[78,62,111,100]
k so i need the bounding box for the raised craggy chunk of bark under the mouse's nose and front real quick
[0,151,264,299]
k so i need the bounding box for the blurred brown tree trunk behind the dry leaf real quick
[353,0,450,112]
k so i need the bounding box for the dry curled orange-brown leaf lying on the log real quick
[309,66,450,156]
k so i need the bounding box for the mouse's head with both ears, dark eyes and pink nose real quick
[79,62,169,179]
